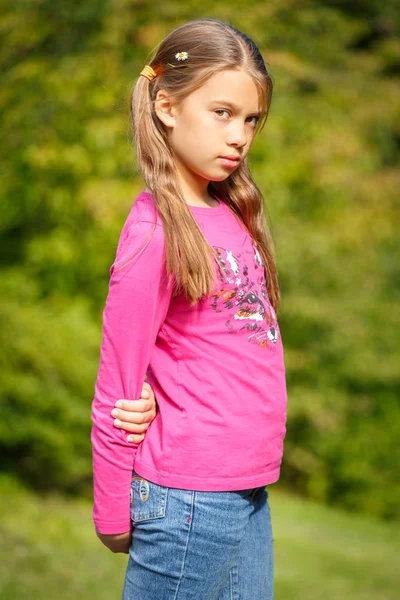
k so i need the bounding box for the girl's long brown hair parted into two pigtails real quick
[131,18,280,311]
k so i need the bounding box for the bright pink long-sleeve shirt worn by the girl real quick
[91,190,287,534]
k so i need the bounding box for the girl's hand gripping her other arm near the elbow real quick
[111,381,157,444]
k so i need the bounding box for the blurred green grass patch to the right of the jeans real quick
[269,486,400,600]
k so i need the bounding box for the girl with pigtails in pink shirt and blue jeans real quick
[91,19,287,600]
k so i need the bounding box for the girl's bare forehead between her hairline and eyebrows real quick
[194,69,260,113]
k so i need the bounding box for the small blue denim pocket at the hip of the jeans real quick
[131,471,168,524]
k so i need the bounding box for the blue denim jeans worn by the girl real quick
[122,471,274,600]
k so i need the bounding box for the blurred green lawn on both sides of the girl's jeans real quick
[0,478,400,600]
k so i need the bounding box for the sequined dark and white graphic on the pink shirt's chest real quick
[211,240,280,351]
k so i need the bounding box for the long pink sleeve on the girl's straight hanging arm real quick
[91,220,173,534]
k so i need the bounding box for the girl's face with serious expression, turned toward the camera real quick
[159,69,260,191]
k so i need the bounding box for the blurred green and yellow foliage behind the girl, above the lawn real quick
[0,0,400,519]
